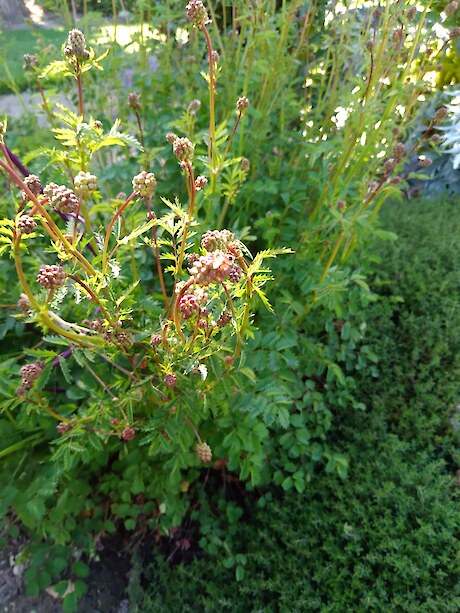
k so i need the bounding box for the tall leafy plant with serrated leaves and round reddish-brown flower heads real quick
[1,1,456,607]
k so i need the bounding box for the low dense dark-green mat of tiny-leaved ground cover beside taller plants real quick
[131,202,460,613]
